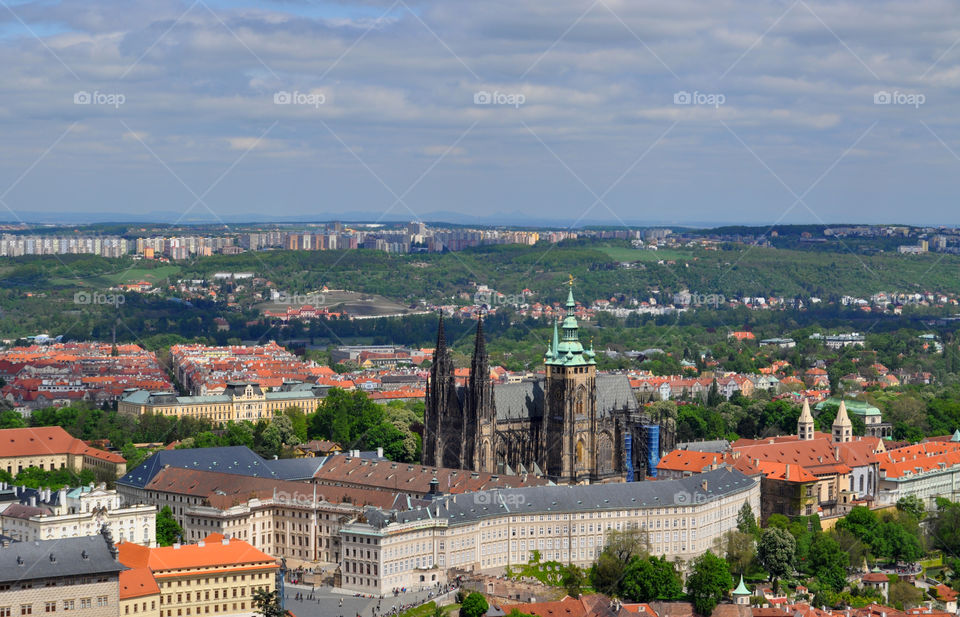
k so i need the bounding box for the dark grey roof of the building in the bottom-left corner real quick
[0,534,124,583]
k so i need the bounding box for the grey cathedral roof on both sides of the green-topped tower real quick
[493,375,637,421]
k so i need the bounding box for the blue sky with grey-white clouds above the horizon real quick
[0,0,960,226]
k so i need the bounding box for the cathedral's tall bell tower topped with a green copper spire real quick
[540,276,597,483]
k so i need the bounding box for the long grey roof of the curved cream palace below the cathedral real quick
[364,467,757,528]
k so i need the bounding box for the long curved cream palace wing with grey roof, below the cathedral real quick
[340,468,760,595]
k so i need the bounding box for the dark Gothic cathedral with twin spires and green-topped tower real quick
[422,286,667,484]
